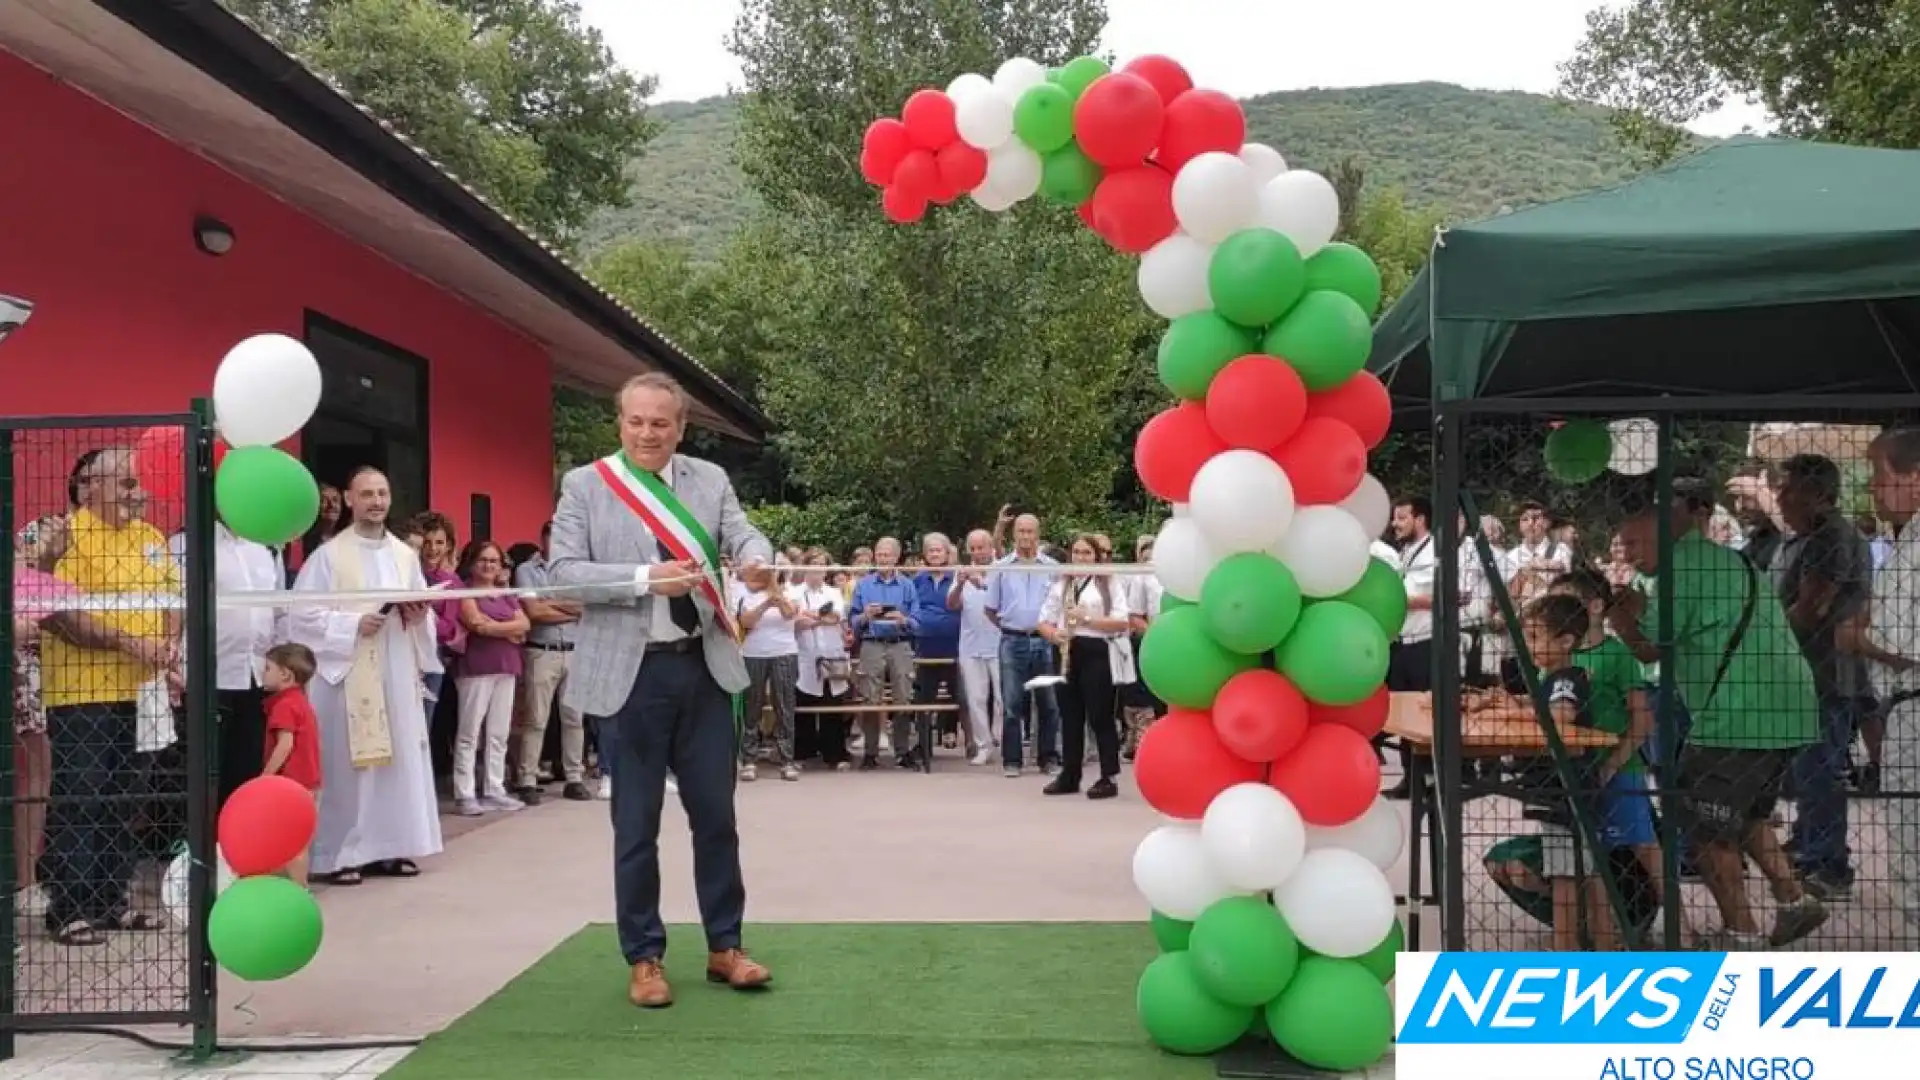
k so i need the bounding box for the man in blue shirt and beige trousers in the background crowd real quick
[849,536,918,771]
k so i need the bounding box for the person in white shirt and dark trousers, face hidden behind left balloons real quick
[167,521,286,805]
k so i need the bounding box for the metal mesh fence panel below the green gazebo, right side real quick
[1415,396,1920,951]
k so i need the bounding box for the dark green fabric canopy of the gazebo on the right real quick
[1367,140,1920,411]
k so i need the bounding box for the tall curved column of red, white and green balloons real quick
[860,56,1407,1070]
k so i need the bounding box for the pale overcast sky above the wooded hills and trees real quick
[580,0,1764,135]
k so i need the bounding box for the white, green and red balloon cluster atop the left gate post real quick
[134,334,321,546]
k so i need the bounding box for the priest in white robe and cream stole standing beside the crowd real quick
[286,469,442,884]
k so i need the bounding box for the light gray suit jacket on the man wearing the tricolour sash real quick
[547,454,774,717]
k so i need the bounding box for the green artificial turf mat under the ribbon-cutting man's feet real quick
[386,922,1213,1080]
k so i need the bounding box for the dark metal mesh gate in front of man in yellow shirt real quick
[0,404,217,1059]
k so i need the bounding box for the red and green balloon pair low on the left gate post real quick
[207,776,321,982]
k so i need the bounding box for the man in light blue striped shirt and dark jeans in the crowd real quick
[987,513,1060,778]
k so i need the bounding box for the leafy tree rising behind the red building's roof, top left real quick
[227,0,657,244]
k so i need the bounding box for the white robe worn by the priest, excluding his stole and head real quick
[286,532,442,874]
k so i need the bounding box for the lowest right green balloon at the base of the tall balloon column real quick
[1267,957,1394,1072]
